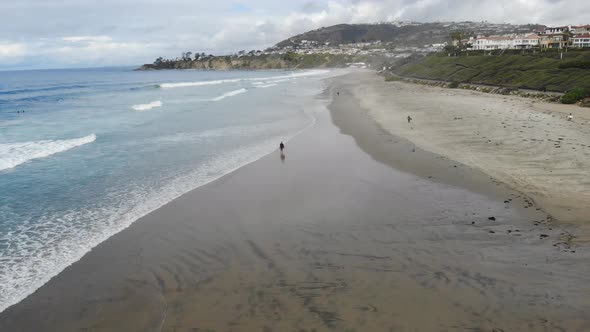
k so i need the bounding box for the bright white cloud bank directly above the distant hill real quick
[190,0,590,56]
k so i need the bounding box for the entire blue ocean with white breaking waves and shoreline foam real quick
[0,68,335,312]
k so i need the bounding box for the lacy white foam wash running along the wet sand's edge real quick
[0,109,315,312]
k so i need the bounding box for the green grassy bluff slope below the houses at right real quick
[394,49,590,92]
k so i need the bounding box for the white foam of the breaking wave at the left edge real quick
[0,134,96,171]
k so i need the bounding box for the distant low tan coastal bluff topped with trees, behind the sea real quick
[136,53,365,70]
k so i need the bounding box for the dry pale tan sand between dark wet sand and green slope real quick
[351,73,590,228]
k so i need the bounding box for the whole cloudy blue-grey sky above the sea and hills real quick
[0,0,590,70]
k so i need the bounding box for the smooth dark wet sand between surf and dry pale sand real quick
[0,73,590,331]
